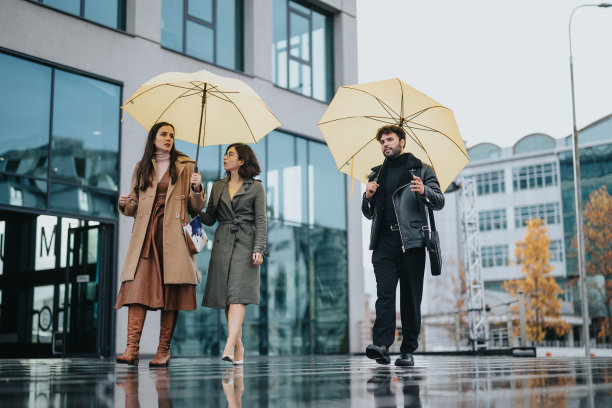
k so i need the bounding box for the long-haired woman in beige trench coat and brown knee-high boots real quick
[115,122,205,366]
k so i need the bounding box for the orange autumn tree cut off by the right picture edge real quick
[582,186,612,343]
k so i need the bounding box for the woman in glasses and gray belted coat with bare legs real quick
[200,143,267,364]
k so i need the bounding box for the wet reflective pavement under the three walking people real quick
[0,355,612,408]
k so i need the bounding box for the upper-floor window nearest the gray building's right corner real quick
[272,0,334,101]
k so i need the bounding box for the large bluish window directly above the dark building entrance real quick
[0,53,121,220]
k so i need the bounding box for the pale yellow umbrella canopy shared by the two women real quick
[121,71,281,166]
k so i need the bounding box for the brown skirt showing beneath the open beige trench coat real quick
[115,204,196,310]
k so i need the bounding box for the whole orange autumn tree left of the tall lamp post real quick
[503,219,570,342]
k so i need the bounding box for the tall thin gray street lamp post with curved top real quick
[569,3,612,357]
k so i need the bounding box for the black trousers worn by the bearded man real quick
[372,231,425,353]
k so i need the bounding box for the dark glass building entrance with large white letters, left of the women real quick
[0,212,114,357]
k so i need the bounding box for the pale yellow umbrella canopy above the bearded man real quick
[318,78,470,191]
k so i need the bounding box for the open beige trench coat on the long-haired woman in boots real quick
[119,156,206,285]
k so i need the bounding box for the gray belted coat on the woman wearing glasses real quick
[200,177,267,309]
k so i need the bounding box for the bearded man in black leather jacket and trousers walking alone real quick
[361,125,444,366]
